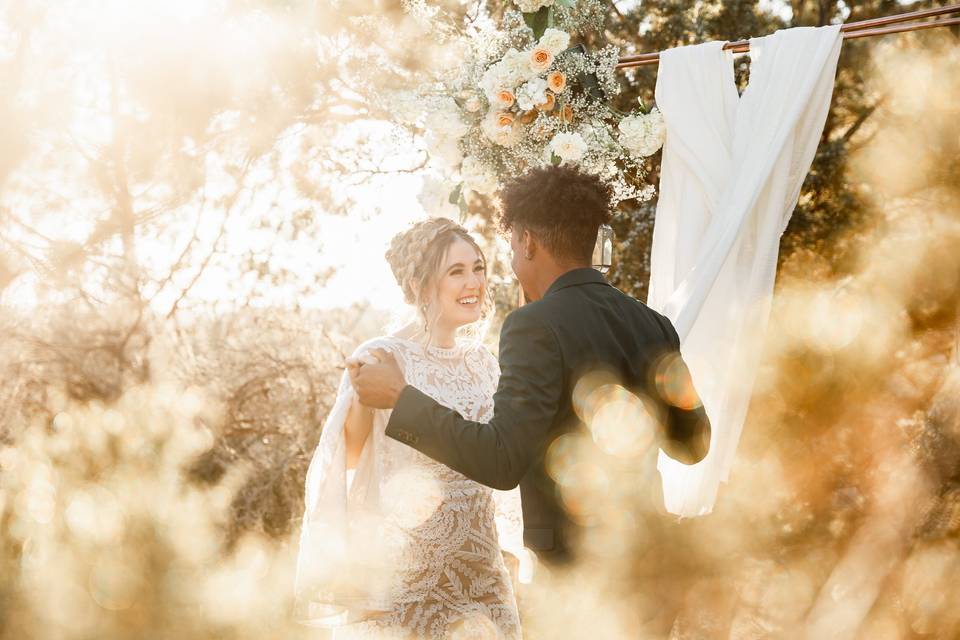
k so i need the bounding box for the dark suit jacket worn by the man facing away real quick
[386,268,710,559]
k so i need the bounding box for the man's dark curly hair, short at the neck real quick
[500,165,613,263]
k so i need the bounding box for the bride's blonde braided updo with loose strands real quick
[385,218,489,319]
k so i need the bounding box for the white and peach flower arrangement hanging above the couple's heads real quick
[394,0,664,211]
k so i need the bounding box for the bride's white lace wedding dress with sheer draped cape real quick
[296,337,523,640]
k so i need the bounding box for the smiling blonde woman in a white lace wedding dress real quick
[296,218,523,640]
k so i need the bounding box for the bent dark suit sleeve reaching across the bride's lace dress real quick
[386,312,563,490]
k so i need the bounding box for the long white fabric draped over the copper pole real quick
[647,25,842,516]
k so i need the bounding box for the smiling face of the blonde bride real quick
[435,239,487,327]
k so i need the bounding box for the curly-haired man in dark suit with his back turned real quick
[351,166,710,566]
